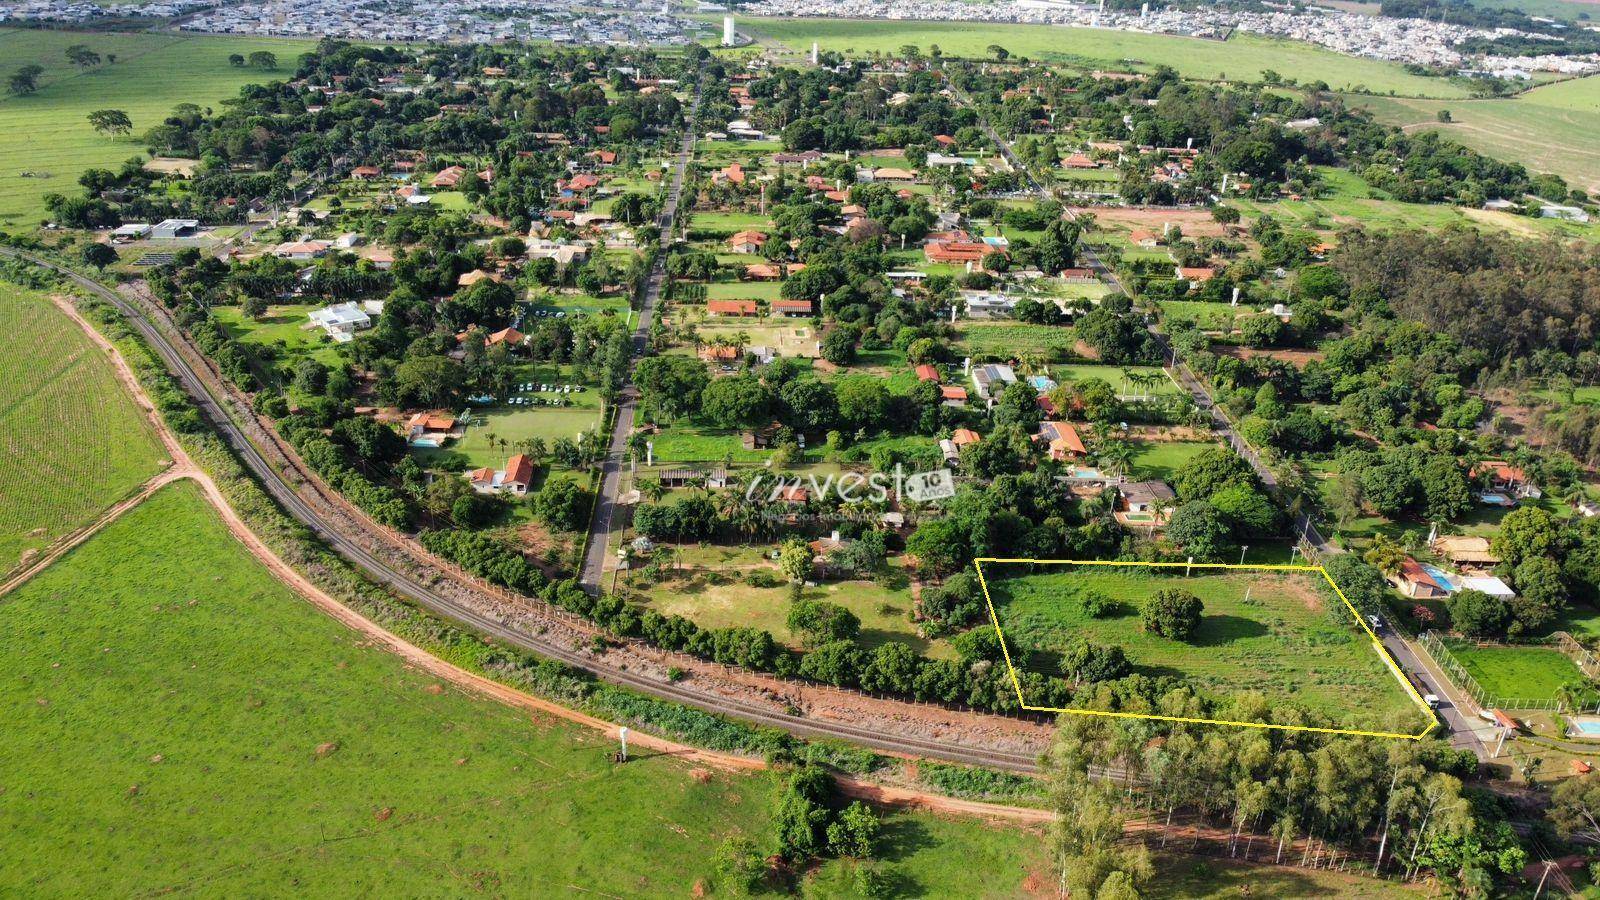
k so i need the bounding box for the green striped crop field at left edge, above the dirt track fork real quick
[0,282,165,572]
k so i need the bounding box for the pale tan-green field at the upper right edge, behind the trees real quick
[1349,77,1600,191]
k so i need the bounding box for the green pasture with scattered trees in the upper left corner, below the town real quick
[0,29,310,227]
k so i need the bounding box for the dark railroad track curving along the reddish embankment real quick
[0,247,1038,773]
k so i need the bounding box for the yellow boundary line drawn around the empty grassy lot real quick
[973,556,1438,740]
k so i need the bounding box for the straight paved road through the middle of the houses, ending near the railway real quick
[578,82,701,594]
